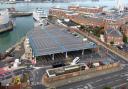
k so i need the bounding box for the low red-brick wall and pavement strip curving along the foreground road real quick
[42,63,121,87]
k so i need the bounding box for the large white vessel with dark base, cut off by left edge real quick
[0,9,13,33]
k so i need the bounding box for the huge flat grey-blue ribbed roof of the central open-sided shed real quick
[28,25,96,56]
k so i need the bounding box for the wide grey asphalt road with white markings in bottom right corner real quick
[57,65,128,89]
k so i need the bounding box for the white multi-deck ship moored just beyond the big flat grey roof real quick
[33,8,47,22]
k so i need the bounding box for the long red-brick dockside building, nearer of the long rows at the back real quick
[49,8,105,27]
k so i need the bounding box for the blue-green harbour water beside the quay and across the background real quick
[0,0,128,52]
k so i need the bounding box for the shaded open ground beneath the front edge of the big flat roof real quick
[36,50,113,66]
